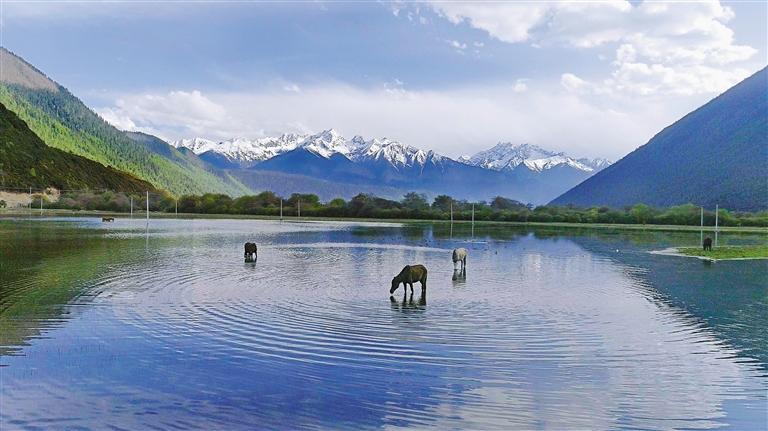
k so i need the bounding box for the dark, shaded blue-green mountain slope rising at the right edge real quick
[551,68,768,211]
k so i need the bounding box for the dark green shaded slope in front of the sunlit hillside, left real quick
[0,100,155,192]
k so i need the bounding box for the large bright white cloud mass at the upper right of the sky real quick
[428,0,757,97]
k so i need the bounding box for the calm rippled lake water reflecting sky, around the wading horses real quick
[0,218,768,430]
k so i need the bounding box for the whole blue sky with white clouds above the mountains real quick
[0,0,768,160]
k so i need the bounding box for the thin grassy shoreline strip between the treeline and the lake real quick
[0,209,768,234]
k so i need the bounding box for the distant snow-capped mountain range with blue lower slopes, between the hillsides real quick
[170,129,610,204]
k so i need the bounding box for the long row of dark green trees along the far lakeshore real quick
[13,191,768,227]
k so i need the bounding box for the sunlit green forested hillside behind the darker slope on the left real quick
[0,50,249,196]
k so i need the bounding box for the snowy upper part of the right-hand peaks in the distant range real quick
[458,142,610,173]
